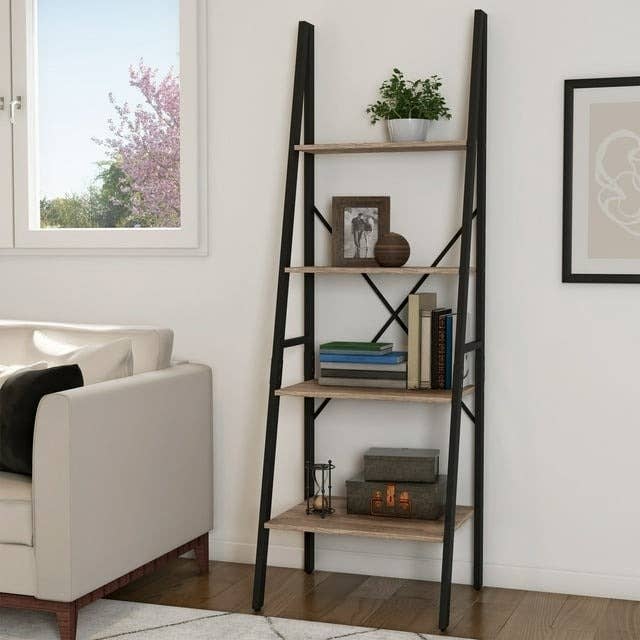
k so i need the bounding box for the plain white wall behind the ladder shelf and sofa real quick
[5,0,640,598]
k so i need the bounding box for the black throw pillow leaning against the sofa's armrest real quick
[0,364,84,475]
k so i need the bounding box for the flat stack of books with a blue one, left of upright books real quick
[319,342,407,389]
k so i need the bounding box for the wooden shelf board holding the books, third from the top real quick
[276,380,474,404]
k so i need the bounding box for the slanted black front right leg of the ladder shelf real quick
[438,11,485,631]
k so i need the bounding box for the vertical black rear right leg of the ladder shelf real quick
[473,11,487,589]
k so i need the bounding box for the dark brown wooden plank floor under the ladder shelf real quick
[111,559,640,640]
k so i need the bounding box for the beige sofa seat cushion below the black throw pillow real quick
[0,471,33,546]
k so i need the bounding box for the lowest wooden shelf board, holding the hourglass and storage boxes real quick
[264,498,473,542]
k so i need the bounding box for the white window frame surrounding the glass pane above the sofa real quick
[0,0,208,255]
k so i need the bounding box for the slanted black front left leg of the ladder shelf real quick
[253,22,311,611]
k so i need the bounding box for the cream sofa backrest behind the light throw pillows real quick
[0,320,173,374]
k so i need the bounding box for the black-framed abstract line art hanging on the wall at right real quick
[562,77,640,283]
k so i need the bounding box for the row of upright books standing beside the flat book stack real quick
[407,293,473,389]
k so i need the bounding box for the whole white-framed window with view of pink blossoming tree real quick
[0,0,206,253]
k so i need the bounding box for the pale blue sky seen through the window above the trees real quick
[37,0,180,197]
